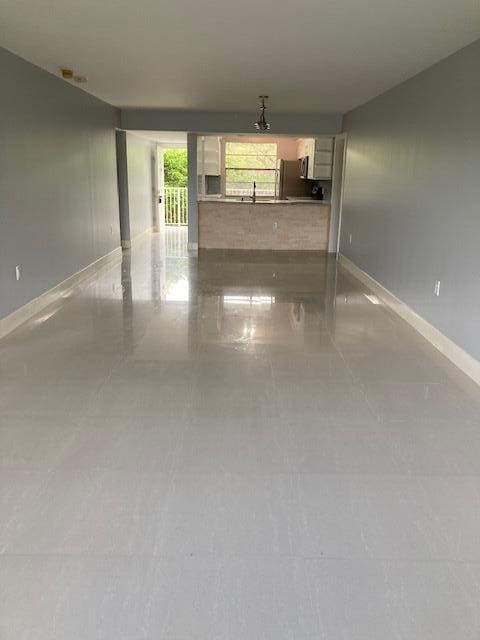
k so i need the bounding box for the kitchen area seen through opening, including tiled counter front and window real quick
[197,135,335,252]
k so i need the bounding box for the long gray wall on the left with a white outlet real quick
[0,49,119,317]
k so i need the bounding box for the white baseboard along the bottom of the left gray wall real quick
[0,247,122,338]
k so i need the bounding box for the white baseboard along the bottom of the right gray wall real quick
[338,254,480,385]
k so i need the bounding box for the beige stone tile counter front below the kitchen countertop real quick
[198,200,330,251]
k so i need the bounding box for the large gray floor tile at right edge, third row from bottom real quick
[274,415,480,475]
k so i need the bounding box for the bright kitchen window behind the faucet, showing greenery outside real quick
[225,142,277,198]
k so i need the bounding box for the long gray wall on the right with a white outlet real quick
[341,41,480,359]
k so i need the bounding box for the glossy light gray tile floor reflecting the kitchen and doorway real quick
[0,230,480,640]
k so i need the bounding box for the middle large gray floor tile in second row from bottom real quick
[155,473,297,556]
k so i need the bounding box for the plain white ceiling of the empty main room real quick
[0,0,480,112]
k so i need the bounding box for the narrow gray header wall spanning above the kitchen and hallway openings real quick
[121,109,342,135]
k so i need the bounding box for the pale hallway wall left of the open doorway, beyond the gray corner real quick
[127,133,154,240]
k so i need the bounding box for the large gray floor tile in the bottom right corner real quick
[308,560,480,640]
